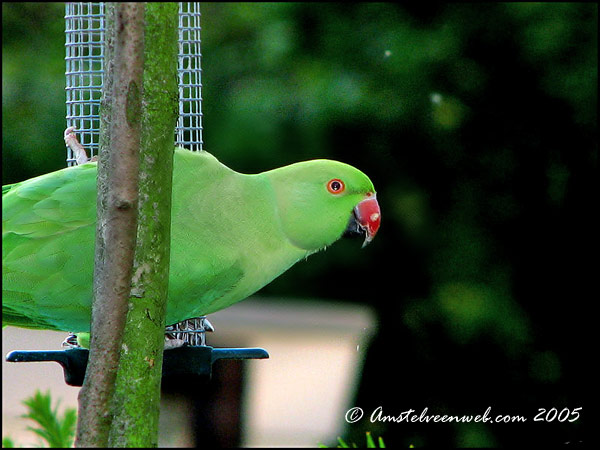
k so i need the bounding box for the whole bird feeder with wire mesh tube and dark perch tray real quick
[6,2,269,386]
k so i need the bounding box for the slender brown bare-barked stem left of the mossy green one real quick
[75,3,144,447]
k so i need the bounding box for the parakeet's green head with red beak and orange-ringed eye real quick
[266,159,381,252]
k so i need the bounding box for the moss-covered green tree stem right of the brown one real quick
[109,2,178,447]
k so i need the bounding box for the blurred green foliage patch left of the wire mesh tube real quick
[2,3,66,184]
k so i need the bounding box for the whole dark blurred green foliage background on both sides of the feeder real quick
[2,3,598,446]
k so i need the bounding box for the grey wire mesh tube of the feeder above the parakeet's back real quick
[65,2,202,166]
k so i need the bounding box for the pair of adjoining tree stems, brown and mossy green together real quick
[76,3,178,447]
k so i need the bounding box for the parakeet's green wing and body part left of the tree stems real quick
[2,164,96,329]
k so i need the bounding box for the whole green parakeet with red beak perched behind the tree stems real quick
[2,148,381,332]
